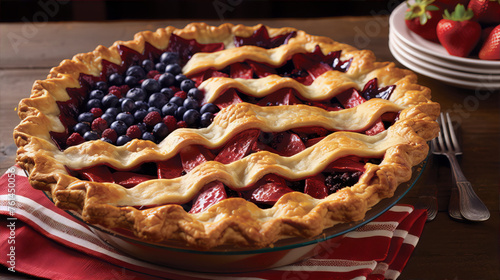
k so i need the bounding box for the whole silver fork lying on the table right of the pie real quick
[432,113,490,222]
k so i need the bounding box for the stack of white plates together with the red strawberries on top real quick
[389,0,500,89]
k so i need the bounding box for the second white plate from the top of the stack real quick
[389,27,500,74]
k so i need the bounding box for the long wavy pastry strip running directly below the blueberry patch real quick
[55,99,403,170]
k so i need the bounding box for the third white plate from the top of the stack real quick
[389,33,500,80]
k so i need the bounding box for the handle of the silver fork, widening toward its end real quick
[447,154,490,221]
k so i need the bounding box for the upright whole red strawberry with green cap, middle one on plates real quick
[437,4,481,57]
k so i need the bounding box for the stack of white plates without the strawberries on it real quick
[389,2,500,91]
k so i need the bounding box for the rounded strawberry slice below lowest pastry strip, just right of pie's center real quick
[249,174,293,205]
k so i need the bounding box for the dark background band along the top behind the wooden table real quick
[0,0,402,22]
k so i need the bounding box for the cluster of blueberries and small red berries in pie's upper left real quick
[67,52,218,146]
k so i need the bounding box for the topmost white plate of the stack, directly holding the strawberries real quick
[389,1,500,69]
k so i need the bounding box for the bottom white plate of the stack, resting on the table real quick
[389,37,500,90]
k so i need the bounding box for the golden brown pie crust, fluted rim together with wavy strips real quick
[14,23,440,249]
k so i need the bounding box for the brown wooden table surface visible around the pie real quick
[0,16,500,280]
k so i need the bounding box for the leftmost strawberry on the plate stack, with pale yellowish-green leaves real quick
[405,0,442,42]
